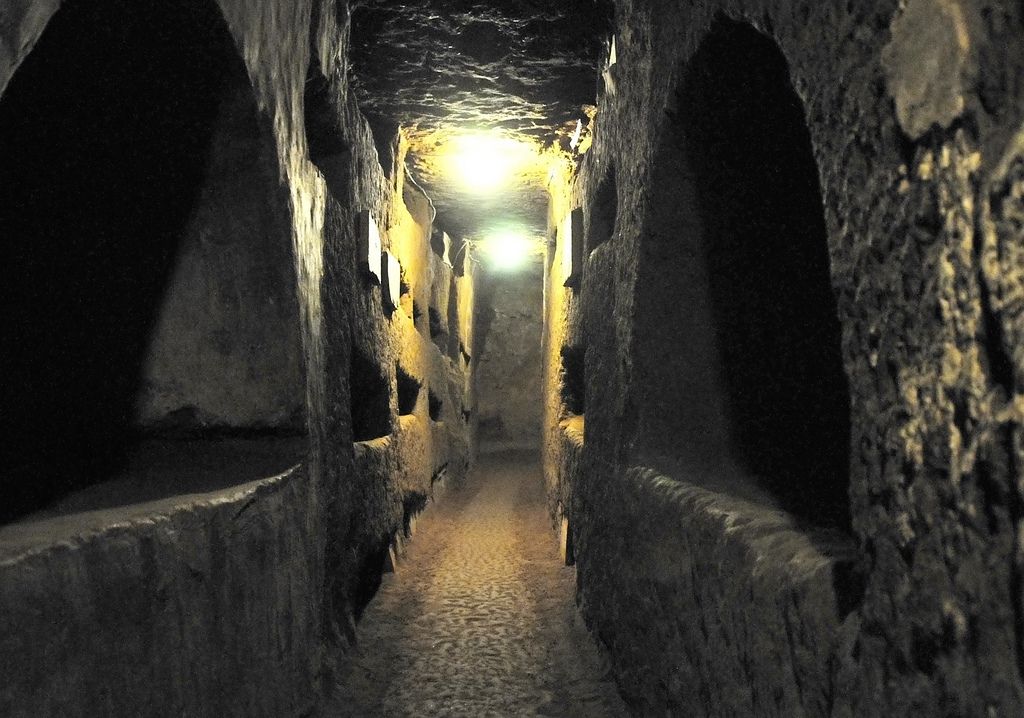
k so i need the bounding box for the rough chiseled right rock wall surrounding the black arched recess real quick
[545,0,1024,716]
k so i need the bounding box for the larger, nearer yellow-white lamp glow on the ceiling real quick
[441,133,539,195]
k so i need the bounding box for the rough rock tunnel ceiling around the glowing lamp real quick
[352,0,611,238]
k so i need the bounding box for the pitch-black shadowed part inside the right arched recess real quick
[678,19,850,525]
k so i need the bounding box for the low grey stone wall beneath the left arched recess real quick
[0,466,323,718]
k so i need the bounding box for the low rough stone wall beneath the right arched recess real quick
[578,467,853,717]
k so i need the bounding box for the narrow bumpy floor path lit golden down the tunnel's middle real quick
[325,451,627,718]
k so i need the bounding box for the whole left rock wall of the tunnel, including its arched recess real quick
[0,0,474,716]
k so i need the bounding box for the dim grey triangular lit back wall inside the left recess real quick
[137,62,305,433]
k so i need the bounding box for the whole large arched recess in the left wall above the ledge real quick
[0,0,304,520]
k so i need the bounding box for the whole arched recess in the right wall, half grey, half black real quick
[638,19,850,525]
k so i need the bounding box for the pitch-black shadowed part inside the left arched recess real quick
[0,0,238,520]
